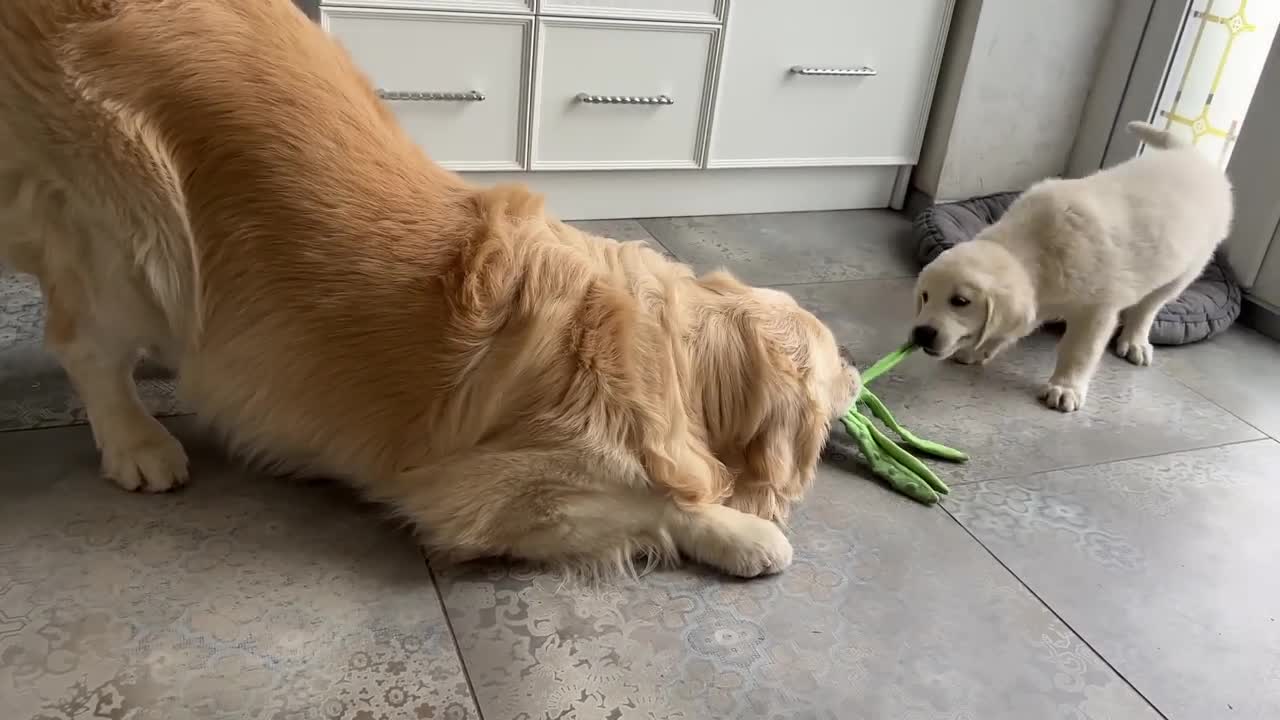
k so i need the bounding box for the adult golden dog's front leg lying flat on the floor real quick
[369,448,791,577]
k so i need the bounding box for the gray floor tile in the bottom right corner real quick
[946,439,1280,720]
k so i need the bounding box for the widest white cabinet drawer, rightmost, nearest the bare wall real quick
[708,0,951,168]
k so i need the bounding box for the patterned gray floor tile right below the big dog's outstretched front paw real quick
[439,469,1157,720]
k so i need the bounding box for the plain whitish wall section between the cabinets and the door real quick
[911,0,1120,202]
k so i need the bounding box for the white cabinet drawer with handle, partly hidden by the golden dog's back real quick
[324,8,534,170]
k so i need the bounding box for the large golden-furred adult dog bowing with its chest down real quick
[0,0,858,577]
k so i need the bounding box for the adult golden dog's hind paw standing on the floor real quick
[102,418,188,492]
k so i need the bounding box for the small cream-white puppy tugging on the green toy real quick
[911,123,1233,413]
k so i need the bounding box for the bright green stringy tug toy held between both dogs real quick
[840,343,969,505]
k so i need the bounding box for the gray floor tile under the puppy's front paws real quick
[787,281,1262,483]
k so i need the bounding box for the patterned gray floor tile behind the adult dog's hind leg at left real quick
[0,266,183,430]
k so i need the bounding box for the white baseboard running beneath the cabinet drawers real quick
[463,165,899,220]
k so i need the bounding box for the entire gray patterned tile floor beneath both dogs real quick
[0,213,1280,720]
